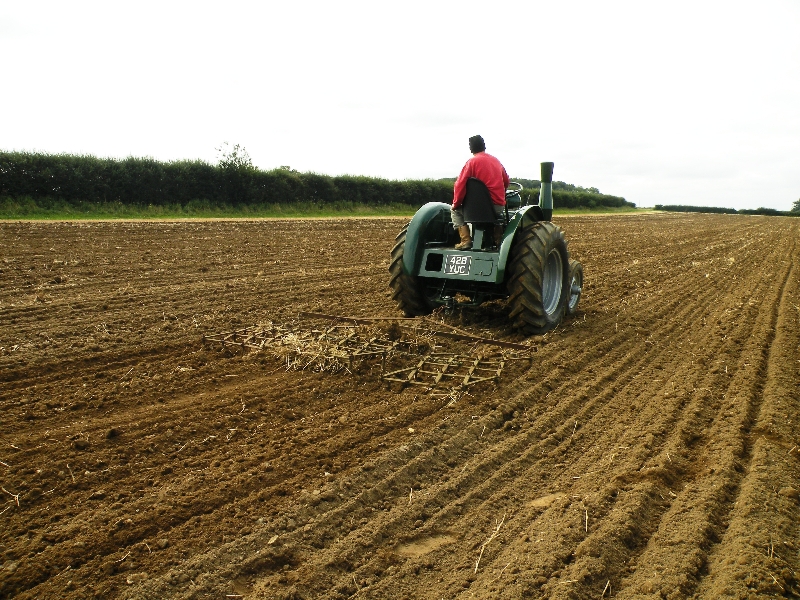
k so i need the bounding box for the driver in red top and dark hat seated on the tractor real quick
[450,135,509,250]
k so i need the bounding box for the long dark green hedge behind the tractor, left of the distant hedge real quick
[0,151,635,208]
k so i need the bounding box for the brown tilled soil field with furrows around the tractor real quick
[0,214,800,600]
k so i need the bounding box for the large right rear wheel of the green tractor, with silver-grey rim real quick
[507,221,570,335]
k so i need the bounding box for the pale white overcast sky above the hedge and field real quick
[0,0,800,210]
